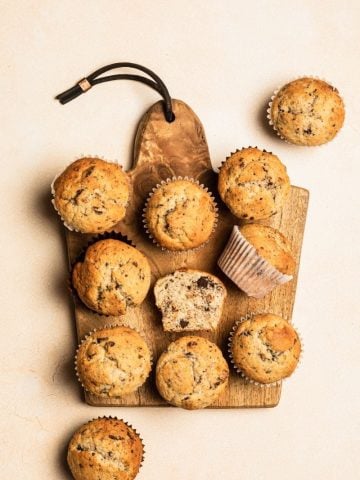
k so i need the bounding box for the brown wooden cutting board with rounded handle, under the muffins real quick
[66,100,309,408]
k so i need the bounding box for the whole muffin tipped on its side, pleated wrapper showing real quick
[218,223,296,298]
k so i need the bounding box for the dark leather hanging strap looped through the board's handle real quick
[55,62,175,122]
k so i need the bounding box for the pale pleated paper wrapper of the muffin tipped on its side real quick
[218,225,293,298]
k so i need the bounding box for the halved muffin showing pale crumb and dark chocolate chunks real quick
[154,269,226,332]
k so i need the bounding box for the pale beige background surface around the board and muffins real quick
[0,0,360,480]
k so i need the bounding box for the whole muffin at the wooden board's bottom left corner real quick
[75,326,151,398]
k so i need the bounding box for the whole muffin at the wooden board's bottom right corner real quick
[229,314,301,384]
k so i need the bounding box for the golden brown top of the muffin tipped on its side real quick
[240,223,296,275]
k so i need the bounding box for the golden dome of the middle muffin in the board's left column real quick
[72,238,151,315]
